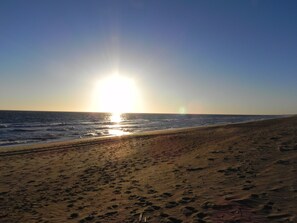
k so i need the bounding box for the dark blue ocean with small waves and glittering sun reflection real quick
[0,111,280,147]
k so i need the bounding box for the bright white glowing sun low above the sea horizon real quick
[93,74,138,114]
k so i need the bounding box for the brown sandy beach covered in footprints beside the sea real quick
[0,117,297,223]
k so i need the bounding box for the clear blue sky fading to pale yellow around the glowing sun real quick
[0,0,297,114]
